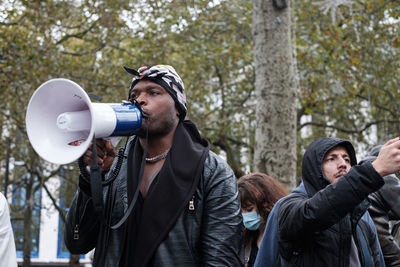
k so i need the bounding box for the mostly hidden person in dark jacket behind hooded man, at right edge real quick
[362,146,400,267]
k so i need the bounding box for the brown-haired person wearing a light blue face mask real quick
[238,172,289,267]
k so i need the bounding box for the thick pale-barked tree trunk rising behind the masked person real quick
[252,0,297,189]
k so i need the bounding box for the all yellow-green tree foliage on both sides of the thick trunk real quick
[0,0,400,184]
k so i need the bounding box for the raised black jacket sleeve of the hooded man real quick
[278,162,384,241]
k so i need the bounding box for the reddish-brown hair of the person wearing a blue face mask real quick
[238,172,289,222]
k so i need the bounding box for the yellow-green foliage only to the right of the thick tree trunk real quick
[295,1,399,145]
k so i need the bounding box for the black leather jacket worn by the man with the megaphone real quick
[65,147,244,267]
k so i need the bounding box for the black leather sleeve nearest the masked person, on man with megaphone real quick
[200,154,244,266]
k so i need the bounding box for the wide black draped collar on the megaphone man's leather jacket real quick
[127,121,209,266]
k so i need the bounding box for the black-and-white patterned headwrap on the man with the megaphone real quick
[124,65,187,121]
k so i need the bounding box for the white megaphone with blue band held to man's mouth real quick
[26,78,142,164]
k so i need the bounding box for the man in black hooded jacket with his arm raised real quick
[276,138,400,267]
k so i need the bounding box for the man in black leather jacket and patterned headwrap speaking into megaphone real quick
[65,65,244,267]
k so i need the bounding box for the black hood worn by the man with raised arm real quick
[301,137,357,197]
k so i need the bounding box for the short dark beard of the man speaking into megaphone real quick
[136,117,174,138]
